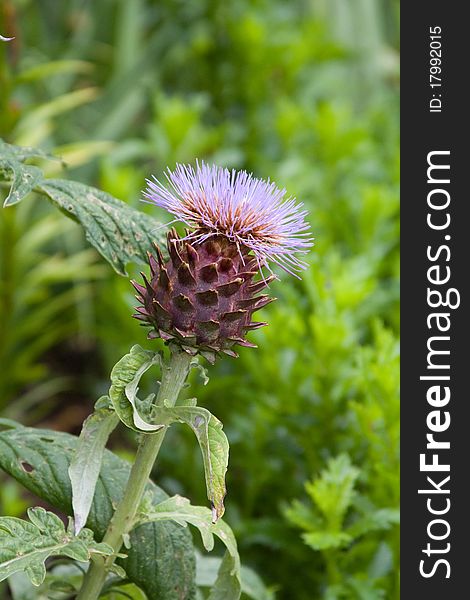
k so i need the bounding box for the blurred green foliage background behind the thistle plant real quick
[0,0,399,600]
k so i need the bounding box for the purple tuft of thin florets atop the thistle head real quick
[144,162,313,275]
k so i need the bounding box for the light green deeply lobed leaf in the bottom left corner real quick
[0,507,113,586]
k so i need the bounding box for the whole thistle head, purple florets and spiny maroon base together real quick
[132,163,312,362]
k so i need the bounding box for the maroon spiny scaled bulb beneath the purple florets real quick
[132,229,274,362]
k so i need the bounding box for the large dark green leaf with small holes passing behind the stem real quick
[0,421,195,600]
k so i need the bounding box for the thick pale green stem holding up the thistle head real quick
[77,350,191,600]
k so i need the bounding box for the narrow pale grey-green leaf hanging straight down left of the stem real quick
[69,396,119,534]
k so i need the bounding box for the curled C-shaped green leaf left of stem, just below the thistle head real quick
[109,345,163,432]
